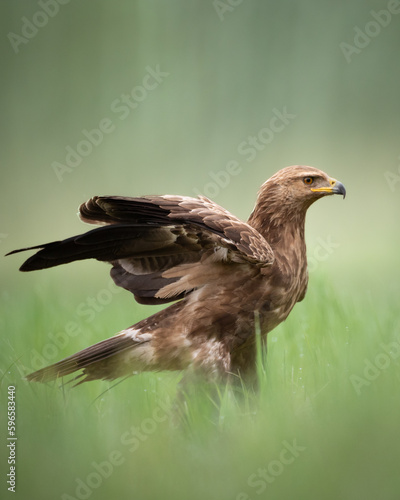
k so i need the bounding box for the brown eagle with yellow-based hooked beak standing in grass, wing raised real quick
[10,165,346,383]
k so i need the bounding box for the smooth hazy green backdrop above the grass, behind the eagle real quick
[0,0,400,285]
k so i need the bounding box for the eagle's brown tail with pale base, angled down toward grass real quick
[26,326,155,383]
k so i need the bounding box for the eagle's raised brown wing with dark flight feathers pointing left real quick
[10,195,274,304]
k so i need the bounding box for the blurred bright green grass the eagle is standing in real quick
[0,276,400,500]
